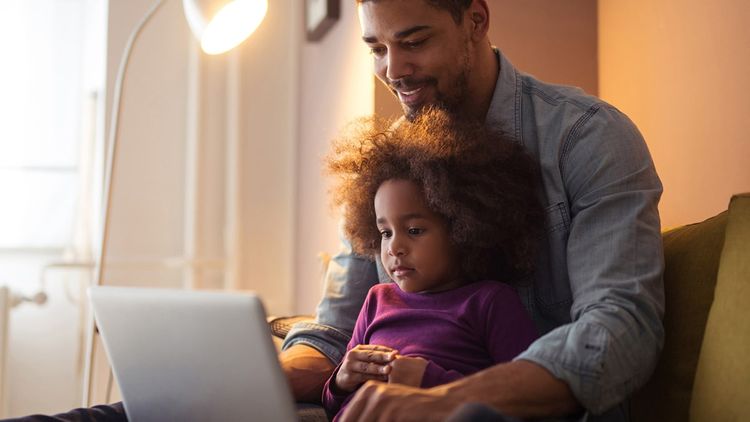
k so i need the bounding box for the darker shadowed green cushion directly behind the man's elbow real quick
[630,212,727,422]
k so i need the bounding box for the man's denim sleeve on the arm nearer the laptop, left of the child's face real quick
[282,223,378,364]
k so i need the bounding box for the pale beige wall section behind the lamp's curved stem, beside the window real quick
[104,0,192,287]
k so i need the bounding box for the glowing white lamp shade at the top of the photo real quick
[182,0,268,54]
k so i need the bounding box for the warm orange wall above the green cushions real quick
[599,0,750,227]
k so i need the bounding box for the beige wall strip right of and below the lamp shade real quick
[238,0,302,315]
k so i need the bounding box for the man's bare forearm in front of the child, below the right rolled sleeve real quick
[444,360,582,418]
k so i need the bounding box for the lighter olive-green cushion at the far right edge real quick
[690,194,750,422]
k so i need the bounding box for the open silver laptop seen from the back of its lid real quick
[88,287,297,422]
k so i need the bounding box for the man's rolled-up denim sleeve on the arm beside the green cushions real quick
[518,104,664,414]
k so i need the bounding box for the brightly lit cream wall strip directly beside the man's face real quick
[293,0,373,313]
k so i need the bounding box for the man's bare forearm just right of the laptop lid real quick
[279,344,335,403]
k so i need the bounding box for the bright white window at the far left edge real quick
[0,0,106,250]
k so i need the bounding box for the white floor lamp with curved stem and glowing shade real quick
[83,0,268,407]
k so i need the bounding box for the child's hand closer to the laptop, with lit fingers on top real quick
[336,344,398,393]
